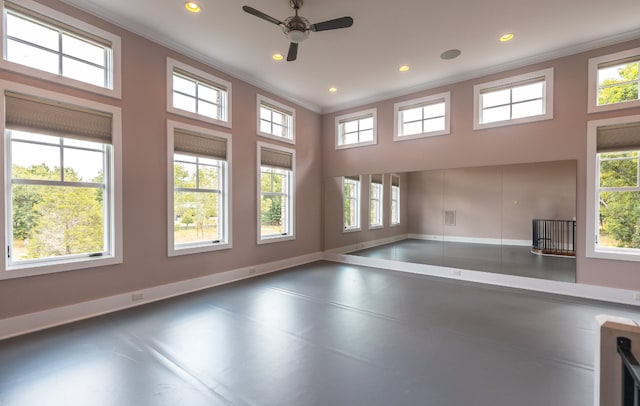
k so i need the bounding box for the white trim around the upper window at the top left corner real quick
[0,0,122,99]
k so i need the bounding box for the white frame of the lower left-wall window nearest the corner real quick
[256,141,296,245]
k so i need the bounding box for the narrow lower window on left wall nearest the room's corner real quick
[258,143,295,244]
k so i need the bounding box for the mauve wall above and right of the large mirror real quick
[322,40,640,290]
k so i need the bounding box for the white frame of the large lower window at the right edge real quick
[585,115,640,262]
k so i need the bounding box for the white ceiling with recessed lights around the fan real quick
[63,0,640,113]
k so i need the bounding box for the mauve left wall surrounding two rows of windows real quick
[0,0,322,319]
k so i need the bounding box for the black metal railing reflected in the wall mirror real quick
[531,219,576,257]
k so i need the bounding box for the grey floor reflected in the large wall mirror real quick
[350,239,576,282]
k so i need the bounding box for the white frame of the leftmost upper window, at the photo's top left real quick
[0,0,122,99]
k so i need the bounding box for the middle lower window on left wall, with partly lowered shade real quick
[167,121,230,255]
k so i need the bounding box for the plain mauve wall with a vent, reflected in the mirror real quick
[407,161,576,241]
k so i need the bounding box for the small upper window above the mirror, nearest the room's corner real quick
[336,109,378,149]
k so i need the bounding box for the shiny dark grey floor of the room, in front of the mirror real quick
[0,262,640,406]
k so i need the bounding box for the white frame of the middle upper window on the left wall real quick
[167,57,233,128]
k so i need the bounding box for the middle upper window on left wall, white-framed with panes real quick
[167,58,231,127]
